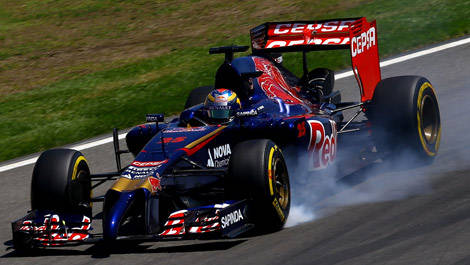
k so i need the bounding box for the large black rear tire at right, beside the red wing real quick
[367,76,441,161]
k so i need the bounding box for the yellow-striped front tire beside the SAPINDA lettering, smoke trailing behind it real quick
[226,139,290,232]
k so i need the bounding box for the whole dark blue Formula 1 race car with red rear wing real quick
[12,17,441,250]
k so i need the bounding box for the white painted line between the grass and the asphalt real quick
[0,37,470,172]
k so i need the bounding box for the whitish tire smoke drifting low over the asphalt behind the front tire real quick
[286,146,442,227]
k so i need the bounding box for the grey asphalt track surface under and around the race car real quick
[0,37,470,265]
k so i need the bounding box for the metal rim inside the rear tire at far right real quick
[420,95,439,144]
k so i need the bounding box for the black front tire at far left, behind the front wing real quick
[31,149,91,216]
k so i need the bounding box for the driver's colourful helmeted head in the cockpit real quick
[204,88,241,123]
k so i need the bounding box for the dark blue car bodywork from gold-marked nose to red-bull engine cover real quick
[103,56,339,239]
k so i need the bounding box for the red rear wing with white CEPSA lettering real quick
[250,17,381,102]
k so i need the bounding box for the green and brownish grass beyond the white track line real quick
[0,0,470,161]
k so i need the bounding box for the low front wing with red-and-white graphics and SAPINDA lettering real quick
[12,200,254,246]
